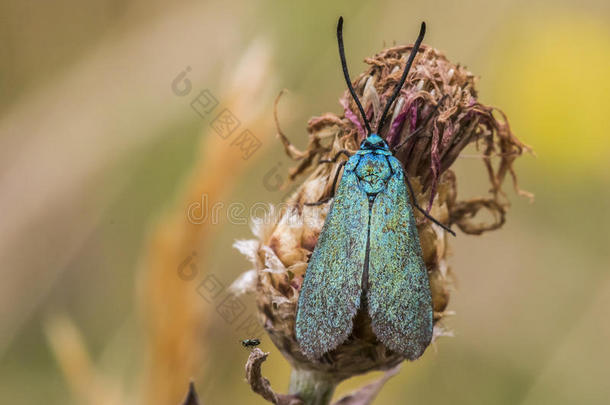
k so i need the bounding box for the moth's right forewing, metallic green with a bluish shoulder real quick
[368,156,433,360]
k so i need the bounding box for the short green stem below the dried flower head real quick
[289,368,337,405]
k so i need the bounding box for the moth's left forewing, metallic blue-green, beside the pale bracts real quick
[296,155,369,359]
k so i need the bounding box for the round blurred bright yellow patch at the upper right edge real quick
[490,10,610,176]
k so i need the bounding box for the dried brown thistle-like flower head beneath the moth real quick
[234,46,529,381]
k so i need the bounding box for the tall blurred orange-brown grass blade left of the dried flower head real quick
[138,41,273,405]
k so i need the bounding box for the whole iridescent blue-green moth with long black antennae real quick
[296,18,453,360]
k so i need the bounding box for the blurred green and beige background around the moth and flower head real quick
[0,0,610,405]
